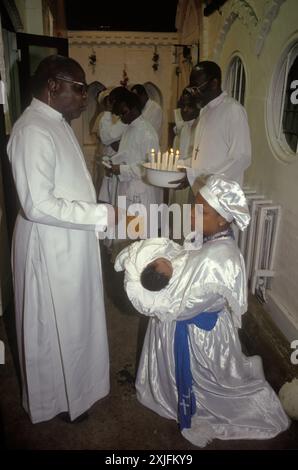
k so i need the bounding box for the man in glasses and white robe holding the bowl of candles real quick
[173,61,251,189]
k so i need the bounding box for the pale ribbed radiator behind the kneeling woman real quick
[238,188,281,302]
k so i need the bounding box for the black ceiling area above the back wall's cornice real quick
[65,0,178,32]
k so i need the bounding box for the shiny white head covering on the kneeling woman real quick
[199,175,250,230]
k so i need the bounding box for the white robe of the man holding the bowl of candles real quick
[187,92,251,186]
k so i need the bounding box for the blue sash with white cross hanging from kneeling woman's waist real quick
[174,311,219,431]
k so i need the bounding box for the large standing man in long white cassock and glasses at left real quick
[8,56,110,423]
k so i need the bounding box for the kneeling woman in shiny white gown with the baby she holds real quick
[115,175,289,447]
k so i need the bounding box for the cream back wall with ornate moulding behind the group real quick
[69,31,178,176]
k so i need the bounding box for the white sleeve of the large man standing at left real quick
[8,126,108,231]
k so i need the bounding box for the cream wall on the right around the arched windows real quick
[180,0,298,339]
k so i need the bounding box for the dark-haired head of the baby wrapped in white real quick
[141,258,173,292]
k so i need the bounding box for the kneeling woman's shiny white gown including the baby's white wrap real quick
[115,236,289,447]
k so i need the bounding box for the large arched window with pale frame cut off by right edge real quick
[267,41,298,162]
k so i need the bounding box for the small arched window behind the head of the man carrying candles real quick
[226,56,246,105]
